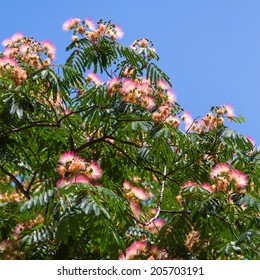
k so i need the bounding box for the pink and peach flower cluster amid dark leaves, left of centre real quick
[56,152,102,188]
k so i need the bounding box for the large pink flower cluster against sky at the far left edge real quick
[0,33,56,85]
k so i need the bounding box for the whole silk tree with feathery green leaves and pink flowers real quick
[0,18,260,259]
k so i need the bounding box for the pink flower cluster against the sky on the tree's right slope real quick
[182,104,235,133]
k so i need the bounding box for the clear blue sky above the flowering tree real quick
[0,0,260,145]
